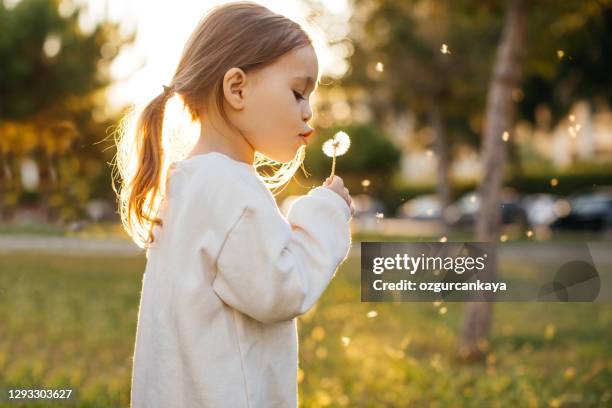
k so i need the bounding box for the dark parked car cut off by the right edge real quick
[551,186,612,231]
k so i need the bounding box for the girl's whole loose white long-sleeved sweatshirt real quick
[131,153,351,408]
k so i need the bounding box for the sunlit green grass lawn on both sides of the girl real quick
[0,254,612,407]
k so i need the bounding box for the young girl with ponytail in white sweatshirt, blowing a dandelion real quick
[117,2,354,408]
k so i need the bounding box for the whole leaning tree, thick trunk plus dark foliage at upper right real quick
[459,0,612,359]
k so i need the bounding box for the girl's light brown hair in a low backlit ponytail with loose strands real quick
[113,2,312,248]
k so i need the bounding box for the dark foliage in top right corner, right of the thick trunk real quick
[516,0,612,126]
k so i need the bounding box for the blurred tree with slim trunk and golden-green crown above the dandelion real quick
[330,0,502,234]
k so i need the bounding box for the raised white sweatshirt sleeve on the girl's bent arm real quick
[212,186,351,323]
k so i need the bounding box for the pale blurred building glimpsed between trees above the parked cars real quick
[387,101,612,184]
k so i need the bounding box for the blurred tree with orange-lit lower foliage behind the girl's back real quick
[0,0,134,220]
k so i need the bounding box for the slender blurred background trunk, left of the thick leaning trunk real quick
[429,97,451,235]
